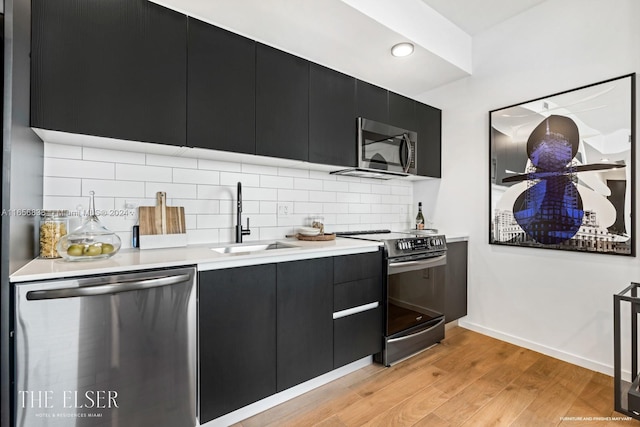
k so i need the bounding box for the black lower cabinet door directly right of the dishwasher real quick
[198,264,276,423]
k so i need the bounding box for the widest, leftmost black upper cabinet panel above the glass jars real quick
[31,0,187,145]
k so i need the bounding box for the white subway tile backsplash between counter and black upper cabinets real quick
[43,142,415,247]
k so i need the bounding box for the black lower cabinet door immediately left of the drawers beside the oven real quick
[277,258,333,391]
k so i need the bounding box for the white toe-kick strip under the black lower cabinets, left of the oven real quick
[198,356,373,427]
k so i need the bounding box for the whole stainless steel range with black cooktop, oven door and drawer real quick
[336,230,447,366]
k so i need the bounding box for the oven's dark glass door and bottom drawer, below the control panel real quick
[381,255,447,366]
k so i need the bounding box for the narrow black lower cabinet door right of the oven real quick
[444,242,467,322]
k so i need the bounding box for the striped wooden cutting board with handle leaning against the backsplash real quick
[138,191,187,236]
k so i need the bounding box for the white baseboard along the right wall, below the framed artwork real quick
[458,318,624,377]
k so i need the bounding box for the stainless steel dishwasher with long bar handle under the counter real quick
[13,267,196,427]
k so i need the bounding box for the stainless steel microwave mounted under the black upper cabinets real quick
[332,117,418,179]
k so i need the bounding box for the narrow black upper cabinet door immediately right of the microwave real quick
[415,102,442,178]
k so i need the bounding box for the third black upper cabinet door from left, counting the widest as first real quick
[256,43,309,161]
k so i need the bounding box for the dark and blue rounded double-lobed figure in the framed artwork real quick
[503,115,584,244]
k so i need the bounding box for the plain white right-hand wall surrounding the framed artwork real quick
[414,0,640,374]
